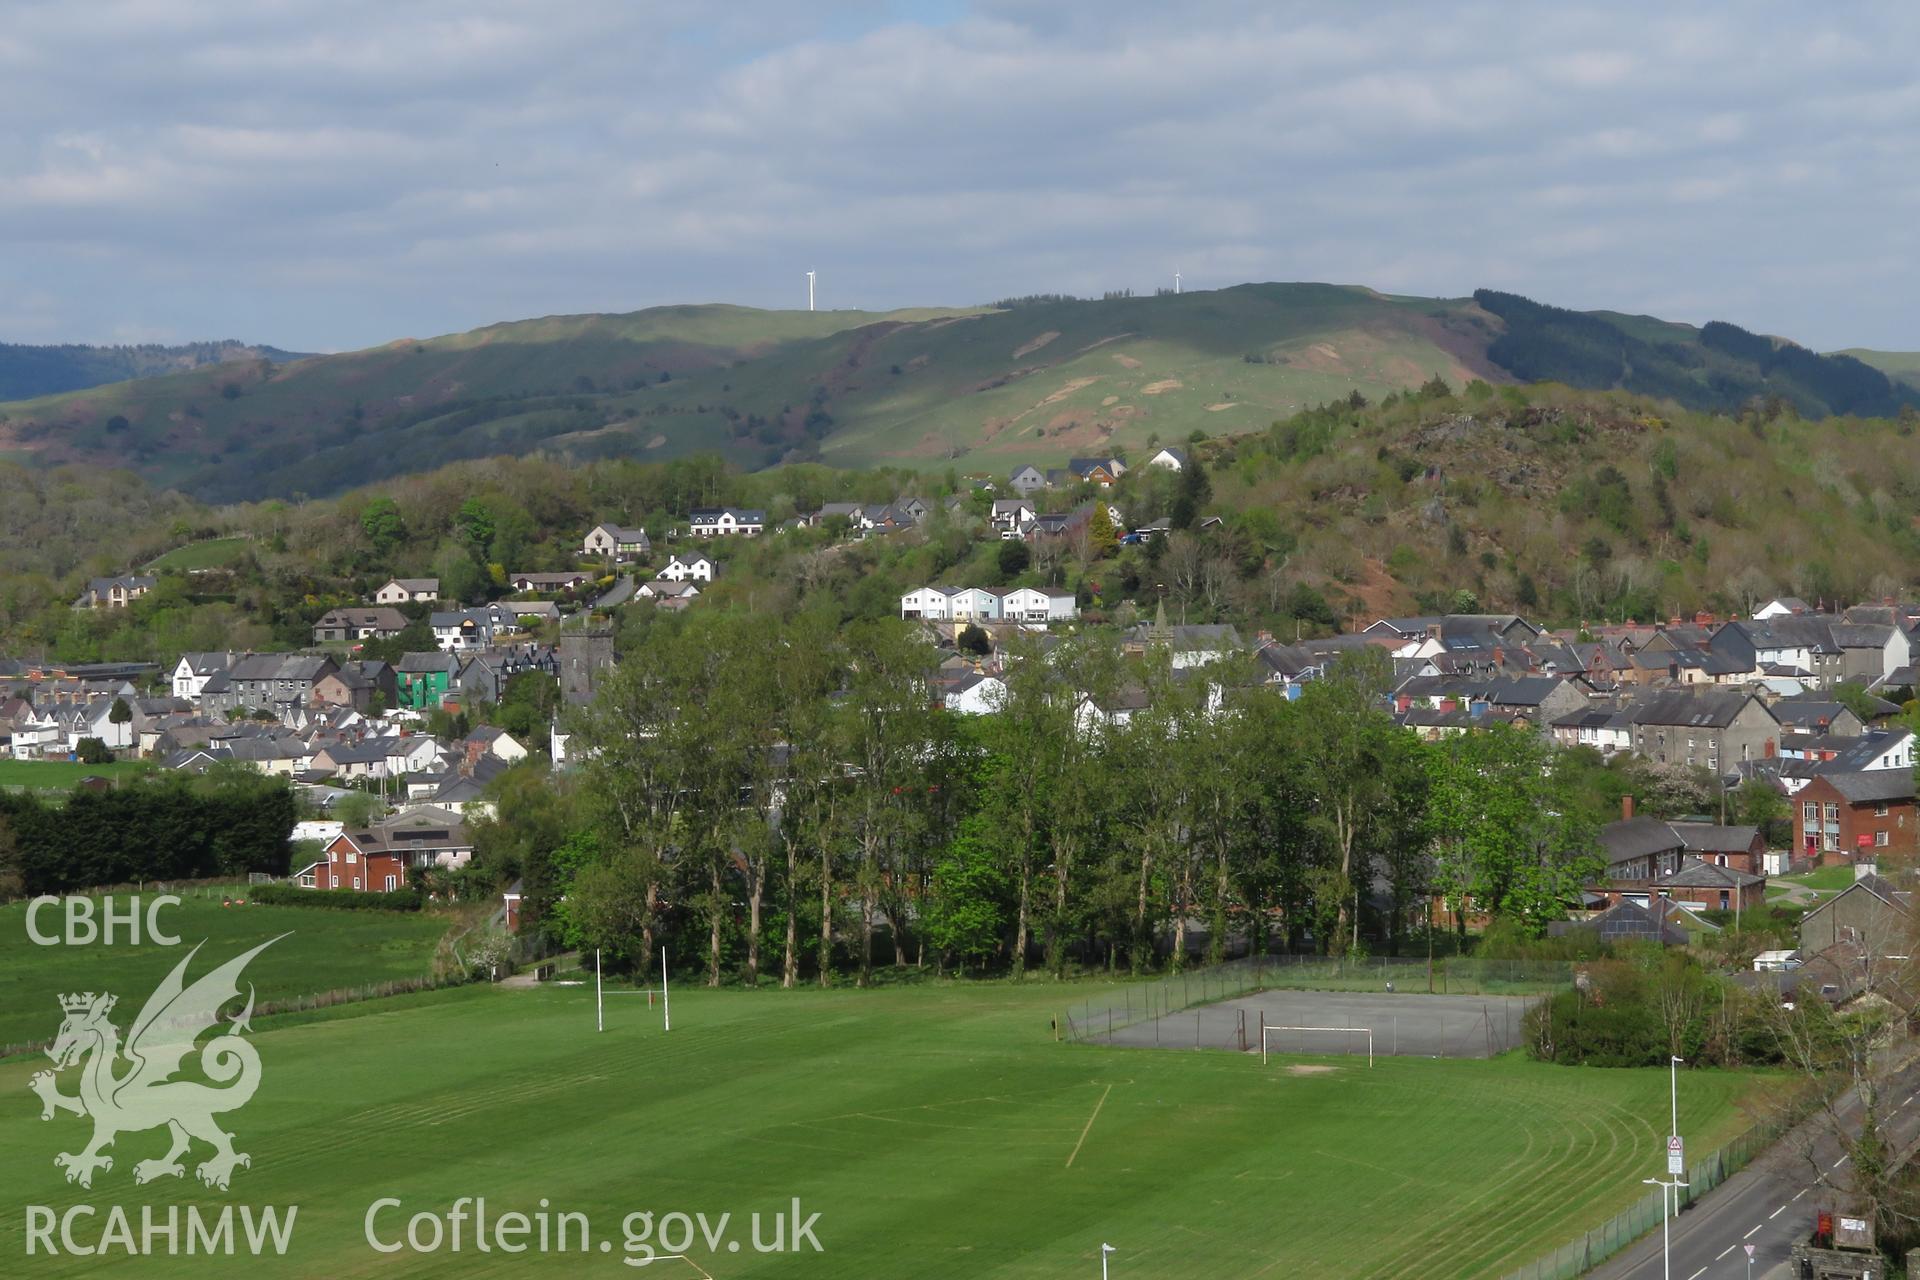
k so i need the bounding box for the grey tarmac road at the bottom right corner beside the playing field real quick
[1588,1063,1920,1280]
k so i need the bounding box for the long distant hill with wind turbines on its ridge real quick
[0,284,1920,501]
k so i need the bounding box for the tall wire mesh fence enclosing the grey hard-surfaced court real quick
[1060,956,1572,1048]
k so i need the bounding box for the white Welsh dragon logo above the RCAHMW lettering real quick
[27,933,286,1192]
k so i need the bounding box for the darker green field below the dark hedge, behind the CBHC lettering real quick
[0,889,447,1046]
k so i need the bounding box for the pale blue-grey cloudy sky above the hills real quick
[0,0,1920,351]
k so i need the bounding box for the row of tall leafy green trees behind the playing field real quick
[522,614,1601,986]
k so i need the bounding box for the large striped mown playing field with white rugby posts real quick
[0,983,1755,1280]
